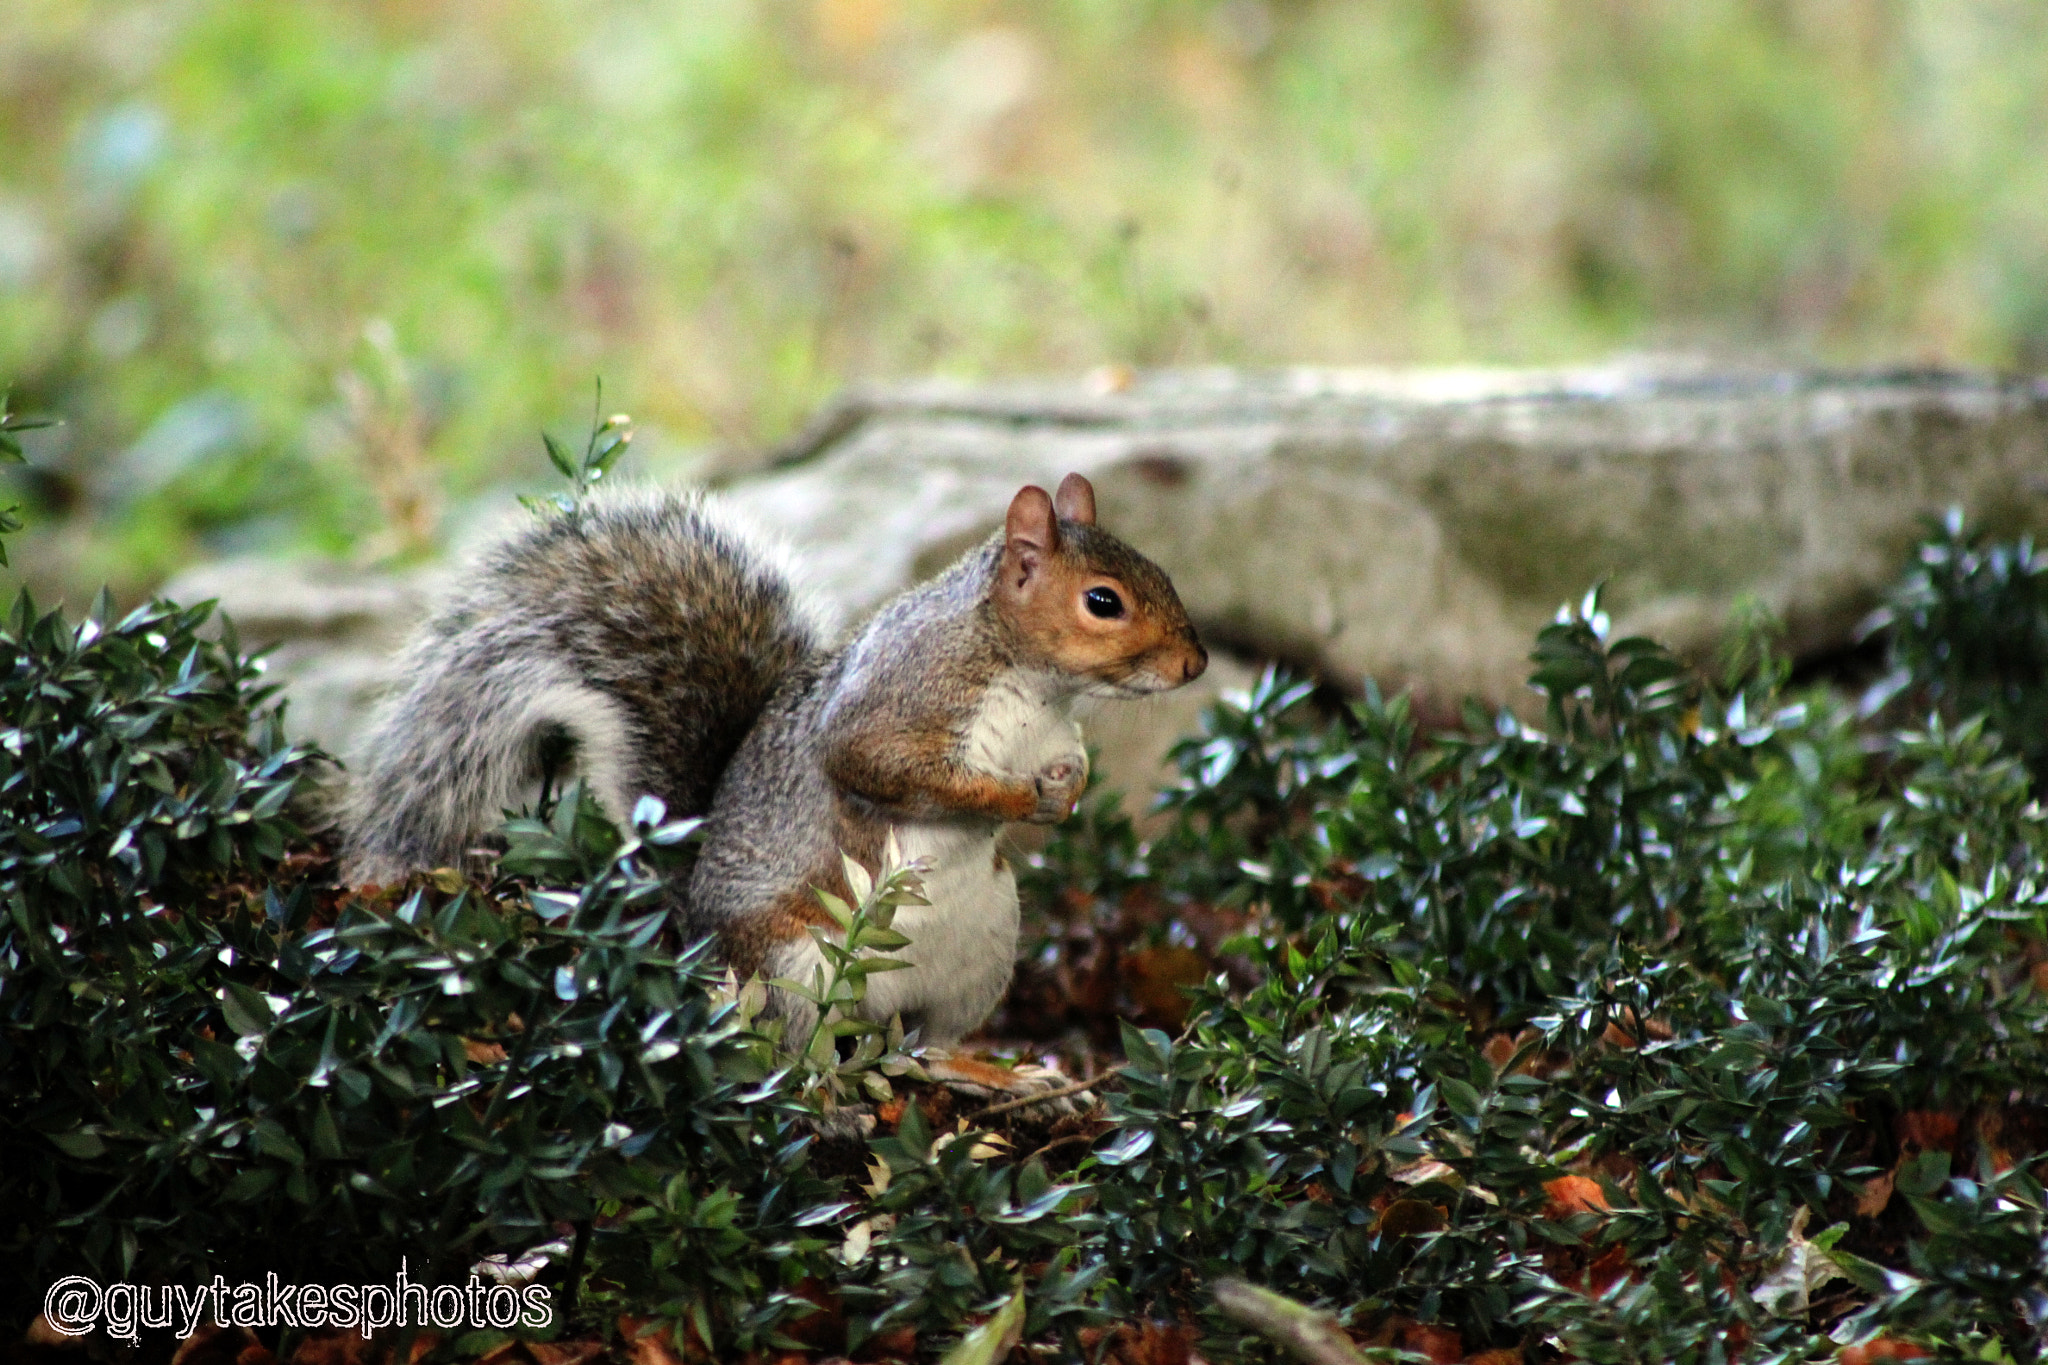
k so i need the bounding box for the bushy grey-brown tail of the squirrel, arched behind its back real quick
[342,489,819,882]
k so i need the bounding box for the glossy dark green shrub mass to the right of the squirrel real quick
[1032,585,2048,1361]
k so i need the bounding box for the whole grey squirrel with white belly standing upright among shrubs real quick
[342,475,1208,1044]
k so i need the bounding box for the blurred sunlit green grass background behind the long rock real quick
[0,0,2048,593]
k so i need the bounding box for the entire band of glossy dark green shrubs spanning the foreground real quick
[12,523,2048,1361]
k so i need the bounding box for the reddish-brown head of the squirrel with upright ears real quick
[993,475,1208,696]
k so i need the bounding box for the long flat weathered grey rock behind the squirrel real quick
[166,366,2048,806]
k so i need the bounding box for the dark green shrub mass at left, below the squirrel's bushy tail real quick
[0,585,838,1345]
